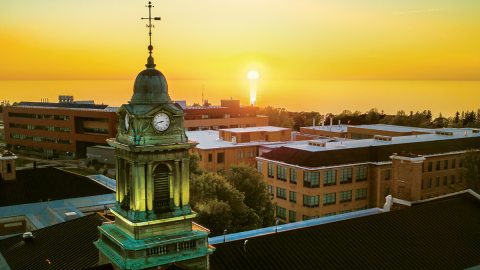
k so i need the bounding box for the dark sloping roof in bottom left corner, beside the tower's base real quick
[0,214,104,269]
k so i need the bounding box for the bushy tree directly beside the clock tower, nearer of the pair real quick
[190,173,261,235]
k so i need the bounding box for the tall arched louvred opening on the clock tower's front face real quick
[153,164,171,211]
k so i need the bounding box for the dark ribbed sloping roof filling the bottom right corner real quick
[210,193,480,270]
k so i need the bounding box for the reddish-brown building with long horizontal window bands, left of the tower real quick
[3,96,117,158]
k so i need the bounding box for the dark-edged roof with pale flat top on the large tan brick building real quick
[259,130,480,168]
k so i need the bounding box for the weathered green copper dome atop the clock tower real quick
[130,55,171,104]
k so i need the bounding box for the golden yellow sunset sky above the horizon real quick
[0,0,480,114]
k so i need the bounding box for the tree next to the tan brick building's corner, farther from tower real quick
[225,165,274,227]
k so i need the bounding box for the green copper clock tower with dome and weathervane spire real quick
[95,2,213,269]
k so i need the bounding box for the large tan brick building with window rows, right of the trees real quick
[257,129,480,222]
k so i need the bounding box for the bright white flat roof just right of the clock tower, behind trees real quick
[187,130,279,150]
